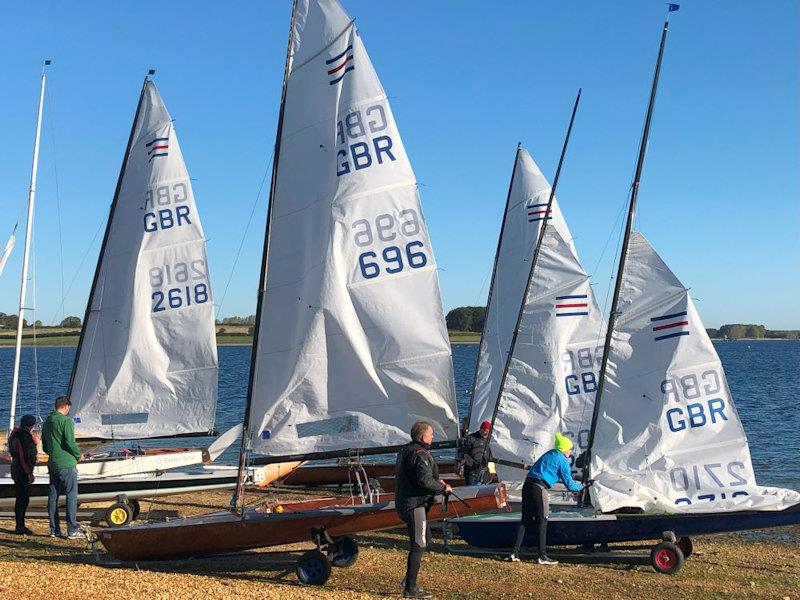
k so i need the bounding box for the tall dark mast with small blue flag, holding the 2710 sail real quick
[583,19,672,480]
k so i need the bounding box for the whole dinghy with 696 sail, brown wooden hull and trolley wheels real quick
[98,0,504,583]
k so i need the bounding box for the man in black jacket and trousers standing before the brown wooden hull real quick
[395,421,452,598]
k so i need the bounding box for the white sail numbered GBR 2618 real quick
[70,80,217,438]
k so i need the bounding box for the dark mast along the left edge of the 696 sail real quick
[238,0,304,514]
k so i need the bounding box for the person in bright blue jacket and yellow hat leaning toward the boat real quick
[508,433,584,565]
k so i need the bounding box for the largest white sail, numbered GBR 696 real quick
[250,0,457,456]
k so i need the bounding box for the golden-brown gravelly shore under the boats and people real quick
[0,491,800,600]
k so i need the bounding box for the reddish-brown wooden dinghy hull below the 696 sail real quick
[96,485,505,561]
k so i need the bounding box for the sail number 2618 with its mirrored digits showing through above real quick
[148,260,210,313]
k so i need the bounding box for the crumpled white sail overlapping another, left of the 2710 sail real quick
[492,225,605,481]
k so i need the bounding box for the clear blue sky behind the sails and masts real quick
[0,0,800,328]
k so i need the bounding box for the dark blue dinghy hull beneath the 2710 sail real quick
[451,504,800,549]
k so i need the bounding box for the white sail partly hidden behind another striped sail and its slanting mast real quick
[469,148,575,429]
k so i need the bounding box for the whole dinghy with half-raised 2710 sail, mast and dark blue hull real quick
[454,21,800,574]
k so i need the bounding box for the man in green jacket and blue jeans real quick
[42,396,85,540]
